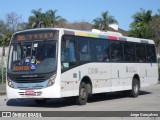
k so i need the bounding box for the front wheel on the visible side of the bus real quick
[76,82,88,105]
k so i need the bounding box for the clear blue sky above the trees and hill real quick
[0,0,160,30]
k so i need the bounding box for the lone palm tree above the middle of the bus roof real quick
[93,11,118,30]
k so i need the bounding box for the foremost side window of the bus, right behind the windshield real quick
[61,36,76,69]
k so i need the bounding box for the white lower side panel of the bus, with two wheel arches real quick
[61,63,158,97]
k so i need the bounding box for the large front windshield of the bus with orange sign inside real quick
[8,40,57,74]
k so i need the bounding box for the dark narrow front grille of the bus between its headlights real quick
[14,77,47,83]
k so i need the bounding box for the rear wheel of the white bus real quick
[130,78,140,97]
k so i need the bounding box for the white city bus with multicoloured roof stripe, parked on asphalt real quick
[7,28,158,105]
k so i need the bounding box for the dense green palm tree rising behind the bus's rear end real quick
[129,8,153,39]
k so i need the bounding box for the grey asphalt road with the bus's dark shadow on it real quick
[0,84,160,120]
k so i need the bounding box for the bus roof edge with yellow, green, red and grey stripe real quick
[12,28,155,44]
